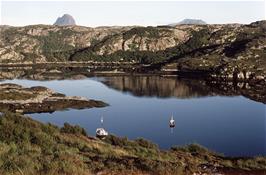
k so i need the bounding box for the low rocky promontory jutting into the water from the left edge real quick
[0,83,107,113]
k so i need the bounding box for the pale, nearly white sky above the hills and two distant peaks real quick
[0,0,265,27]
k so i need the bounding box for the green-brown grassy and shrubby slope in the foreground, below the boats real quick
[0,113,266,175]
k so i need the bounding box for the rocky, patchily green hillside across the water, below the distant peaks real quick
[0,21,266,80]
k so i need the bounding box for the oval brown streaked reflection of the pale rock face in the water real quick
[103,76,211,98]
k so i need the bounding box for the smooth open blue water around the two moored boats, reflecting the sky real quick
[2,79,266,156]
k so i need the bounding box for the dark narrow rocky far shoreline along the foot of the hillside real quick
[0,61,266,84]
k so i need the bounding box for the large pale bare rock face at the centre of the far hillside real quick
[96,27,190,55]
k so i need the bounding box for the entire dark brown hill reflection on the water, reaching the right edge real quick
[101,76,266,103]
